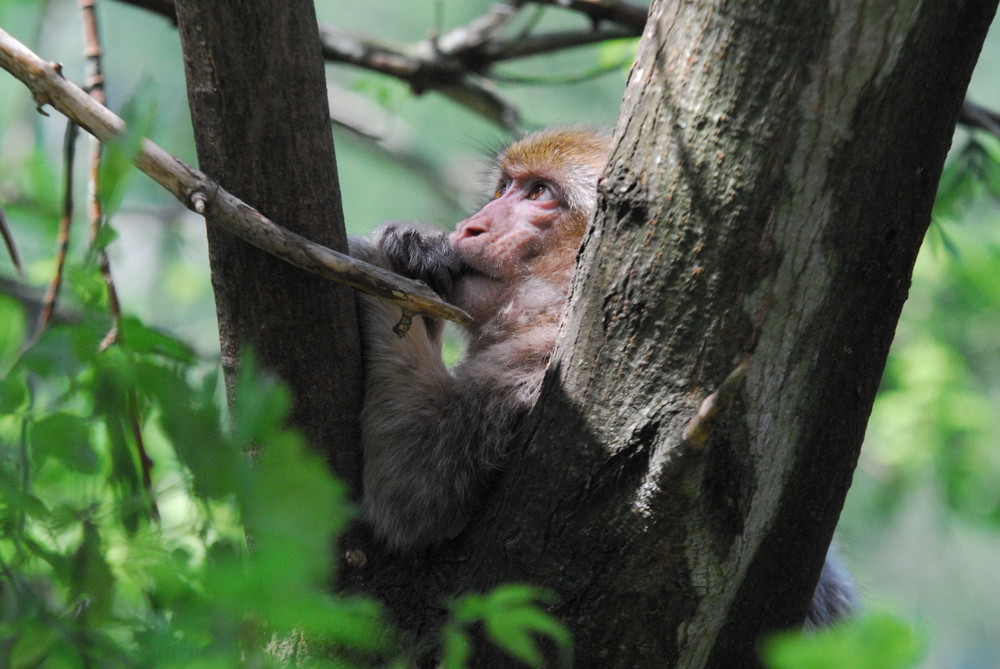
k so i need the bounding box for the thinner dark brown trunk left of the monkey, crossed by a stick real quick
[176,0,361,489]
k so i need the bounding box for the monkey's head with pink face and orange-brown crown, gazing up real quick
[449,128,611,320]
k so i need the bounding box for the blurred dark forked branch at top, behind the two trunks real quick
[105,0,647,131]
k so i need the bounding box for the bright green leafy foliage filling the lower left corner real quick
[0,276,391,667]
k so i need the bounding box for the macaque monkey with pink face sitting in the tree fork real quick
[351,128,841,622]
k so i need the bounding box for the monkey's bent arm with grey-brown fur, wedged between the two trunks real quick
[351,239,527,548]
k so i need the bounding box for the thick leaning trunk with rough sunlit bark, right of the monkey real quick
[344,0,996,669]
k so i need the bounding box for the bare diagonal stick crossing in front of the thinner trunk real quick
[0,30,471,323]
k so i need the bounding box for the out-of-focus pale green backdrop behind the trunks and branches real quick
[0,0,1000,669]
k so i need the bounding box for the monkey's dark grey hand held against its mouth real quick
[375,223,462,300]
